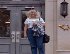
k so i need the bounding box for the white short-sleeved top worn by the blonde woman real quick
[24,18,45,28]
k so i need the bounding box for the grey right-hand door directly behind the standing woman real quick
[16,6,44,54]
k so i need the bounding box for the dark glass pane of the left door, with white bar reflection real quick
[0,9,10,37]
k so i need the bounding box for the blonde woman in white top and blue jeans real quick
[24,10,45,54]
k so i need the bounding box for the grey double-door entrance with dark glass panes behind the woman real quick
[0,6,44,54]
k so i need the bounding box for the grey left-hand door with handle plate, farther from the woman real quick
[0,8,16,54]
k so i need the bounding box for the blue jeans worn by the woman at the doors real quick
[28,28,44,54]
